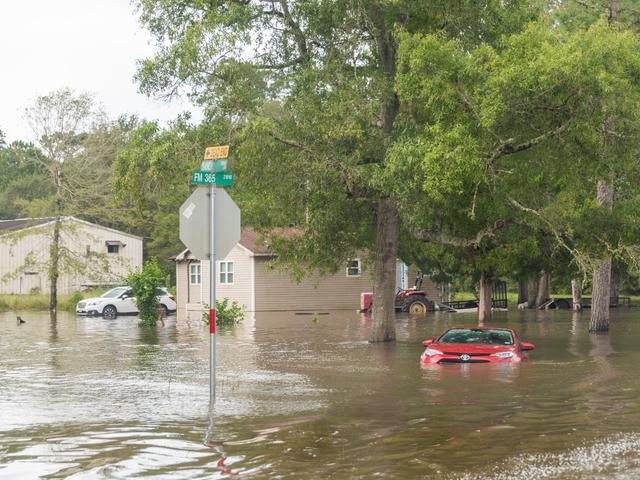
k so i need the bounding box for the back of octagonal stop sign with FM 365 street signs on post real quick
[179,145,240,411]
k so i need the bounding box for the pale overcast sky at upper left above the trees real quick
[0,0,200,141]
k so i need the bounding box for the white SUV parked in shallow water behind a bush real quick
[76,286,177,317]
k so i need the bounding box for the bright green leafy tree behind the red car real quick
[386,19,640,318]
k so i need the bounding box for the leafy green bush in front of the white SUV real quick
[127,258,165,326]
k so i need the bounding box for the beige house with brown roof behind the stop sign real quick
[174,228,437,312]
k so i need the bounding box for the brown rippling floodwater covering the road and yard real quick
[0,309,640,480]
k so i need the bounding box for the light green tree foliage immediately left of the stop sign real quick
[113,118,226,278]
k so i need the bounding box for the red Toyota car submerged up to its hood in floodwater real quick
[420,327,535,364]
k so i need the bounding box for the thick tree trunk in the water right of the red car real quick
[589,180,613,332]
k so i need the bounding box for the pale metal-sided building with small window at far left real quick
[0,217,142,294]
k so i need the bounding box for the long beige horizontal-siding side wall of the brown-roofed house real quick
[254,256,373,311]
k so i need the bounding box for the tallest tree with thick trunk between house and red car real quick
[138,0,538,341]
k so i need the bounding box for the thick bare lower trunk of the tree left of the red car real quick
[369,198,400,342]
